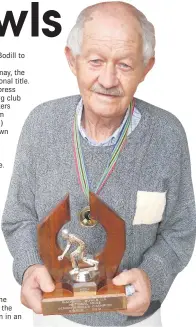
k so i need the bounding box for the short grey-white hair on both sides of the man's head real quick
[67,2,156,65]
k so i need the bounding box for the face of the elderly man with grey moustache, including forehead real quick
[68,14,154,118]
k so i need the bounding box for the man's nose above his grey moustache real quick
[98,63,118,89]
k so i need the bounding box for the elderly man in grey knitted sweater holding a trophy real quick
[2,2,196,326]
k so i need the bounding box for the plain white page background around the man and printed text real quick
[0,0,196,327]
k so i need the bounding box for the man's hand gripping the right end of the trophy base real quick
[113,268,151,316]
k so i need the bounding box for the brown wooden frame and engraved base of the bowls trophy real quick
[38,192,127,315]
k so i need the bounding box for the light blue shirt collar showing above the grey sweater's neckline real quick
[76,98,141,146]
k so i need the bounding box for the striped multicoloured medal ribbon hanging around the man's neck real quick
[73,100,134,200]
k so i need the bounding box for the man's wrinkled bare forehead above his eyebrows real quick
[82,12,142,56]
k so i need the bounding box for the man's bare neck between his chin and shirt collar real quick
[81,110,125,142]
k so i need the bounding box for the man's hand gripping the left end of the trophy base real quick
[21,264,55,314]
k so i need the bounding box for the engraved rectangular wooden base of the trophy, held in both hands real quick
[42,285,127,315]
